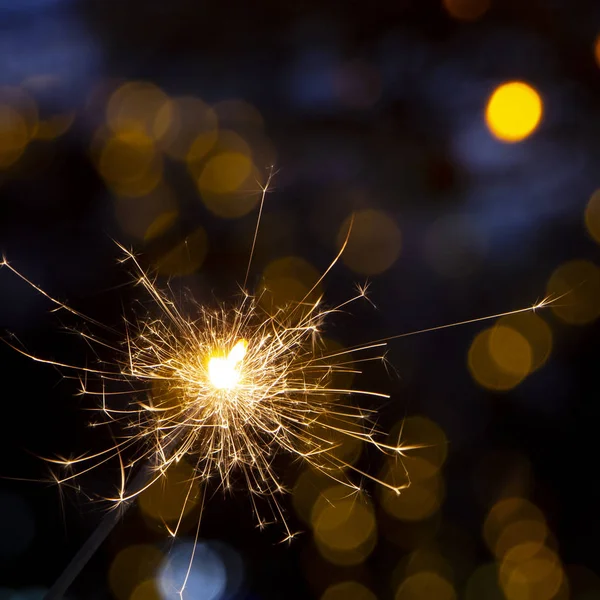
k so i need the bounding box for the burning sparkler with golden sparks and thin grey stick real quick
[0,171,550,599]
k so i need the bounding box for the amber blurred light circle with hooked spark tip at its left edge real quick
[379,457,444,521]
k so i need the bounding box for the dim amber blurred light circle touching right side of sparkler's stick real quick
[138,460,199,522]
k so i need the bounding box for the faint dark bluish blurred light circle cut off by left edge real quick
[0,493,35,560]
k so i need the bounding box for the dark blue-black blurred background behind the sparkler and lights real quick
[0,0,600,600]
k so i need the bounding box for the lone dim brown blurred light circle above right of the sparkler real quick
[337,209,402,275]
